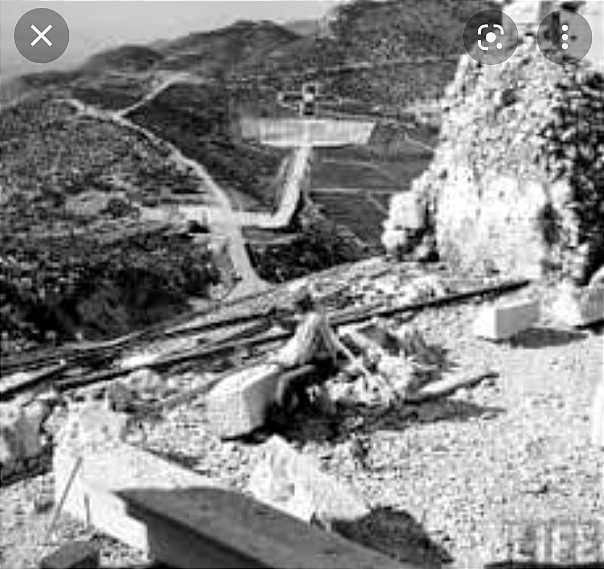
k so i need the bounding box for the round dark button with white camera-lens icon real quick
[463,10,518,65]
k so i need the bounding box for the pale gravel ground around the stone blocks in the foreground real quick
[0,272,604,569]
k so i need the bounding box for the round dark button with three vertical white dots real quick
[537,10,592,64]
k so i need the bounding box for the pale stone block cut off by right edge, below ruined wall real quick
[552,284,604,326]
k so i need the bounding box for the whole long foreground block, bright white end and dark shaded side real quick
[55,444,406,569]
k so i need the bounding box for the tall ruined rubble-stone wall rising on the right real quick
[383,37,604,284]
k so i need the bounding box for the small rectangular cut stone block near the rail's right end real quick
[473,300,540,341]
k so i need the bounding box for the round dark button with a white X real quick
[15,8,69,63]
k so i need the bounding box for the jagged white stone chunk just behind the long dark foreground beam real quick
[247,436,370,524]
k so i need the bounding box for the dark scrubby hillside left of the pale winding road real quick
[0,96,218,351]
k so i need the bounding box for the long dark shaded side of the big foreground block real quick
[120,487,408,569]
